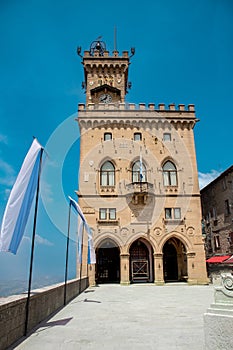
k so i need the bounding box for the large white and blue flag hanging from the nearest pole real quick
[0,139,43,254]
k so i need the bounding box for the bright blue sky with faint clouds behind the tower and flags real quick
[0,0,233,296]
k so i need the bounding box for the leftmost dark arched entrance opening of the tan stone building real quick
[96,239,120,283]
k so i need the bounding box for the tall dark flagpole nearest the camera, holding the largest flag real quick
[24,148,44,336]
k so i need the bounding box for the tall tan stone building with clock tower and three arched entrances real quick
[77,41,207,284]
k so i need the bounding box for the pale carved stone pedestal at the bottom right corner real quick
[204,273,233,350]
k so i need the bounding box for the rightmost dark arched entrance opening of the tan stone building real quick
[163,237,187,282]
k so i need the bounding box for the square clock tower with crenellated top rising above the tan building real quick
[77,40,134,104]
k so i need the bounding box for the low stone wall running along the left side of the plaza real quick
[0,278,88,350]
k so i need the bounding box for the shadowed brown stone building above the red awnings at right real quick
[201,166,233,258]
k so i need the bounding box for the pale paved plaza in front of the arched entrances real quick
[11,284,214,350]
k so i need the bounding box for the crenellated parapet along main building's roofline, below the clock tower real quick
[77,103,198,130]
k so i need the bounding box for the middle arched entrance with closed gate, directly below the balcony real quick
[129,239,153,283]
